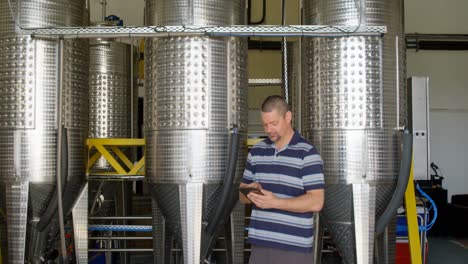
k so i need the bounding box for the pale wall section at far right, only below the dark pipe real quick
[407,50,468,198]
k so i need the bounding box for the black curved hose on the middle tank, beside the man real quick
[204,128,240,256]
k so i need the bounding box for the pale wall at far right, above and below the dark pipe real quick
[405,0,468,201]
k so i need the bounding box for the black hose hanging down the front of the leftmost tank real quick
[36,128,68,232]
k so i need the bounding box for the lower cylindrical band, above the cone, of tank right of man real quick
[309,129,399,184]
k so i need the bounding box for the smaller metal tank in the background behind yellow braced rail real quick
[88,38,138,258]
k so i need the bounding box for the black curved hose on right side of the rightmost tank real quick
[375,131,413,235]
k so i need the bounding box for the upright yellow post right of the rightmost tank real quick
[405,157,422,264]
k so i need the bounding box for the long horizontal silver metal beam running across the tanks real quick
[22,25,387,39]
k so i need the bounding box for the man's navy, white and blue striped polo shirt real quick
[242,131,325,252]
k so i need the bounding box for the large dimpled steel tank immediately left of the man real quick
[145,0,247,264]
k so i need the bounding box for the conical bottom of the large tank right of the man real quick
[321,183,394,263]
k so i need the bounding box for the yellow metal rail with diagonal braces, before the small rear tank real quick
[86,138,145,176]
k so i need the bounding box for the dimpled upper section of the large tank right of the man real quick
[304,0,406,128]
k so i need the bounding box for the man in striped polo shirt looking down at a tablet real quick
[239,95,325,264]
